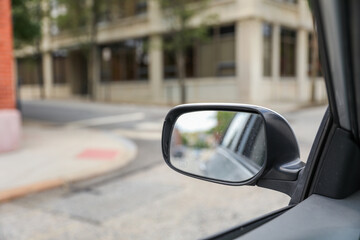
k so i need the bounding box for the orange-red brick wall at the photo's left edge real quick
[0,0,15,109]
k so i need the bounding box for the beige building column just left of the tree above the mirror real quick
[149,35,163,103]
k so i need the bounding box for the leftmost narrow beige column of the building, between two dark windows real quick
[42,52,54,98]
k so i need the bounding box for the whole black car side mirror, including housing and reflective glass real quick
[162,104,304,195]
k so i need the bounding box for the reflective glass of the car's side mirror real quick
[170,111,266,182]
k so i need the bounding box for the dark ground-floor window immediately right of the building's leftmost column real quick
[53,50,68,84]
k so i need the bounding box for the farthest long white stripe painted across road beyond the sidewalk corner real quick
[67,112,145,128]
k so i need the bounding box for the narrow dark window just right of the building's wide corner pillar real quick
[263,23,272,76]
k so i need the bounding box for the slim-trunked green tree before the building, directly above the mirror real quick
[158,0,217,103]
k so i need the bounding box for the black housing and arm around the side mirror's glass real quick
[162,104,305,195]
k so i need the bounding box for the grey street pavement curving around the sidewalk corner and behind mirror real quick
[0,101,325,240]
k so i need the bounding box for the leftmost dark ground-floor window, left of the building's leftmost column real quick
[17,55,42,85]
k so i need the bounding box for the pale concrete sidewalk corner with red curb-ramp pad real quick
[0,121,137,202]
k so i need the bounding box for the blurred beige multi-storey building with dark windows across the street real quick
[16,0,326,104]
